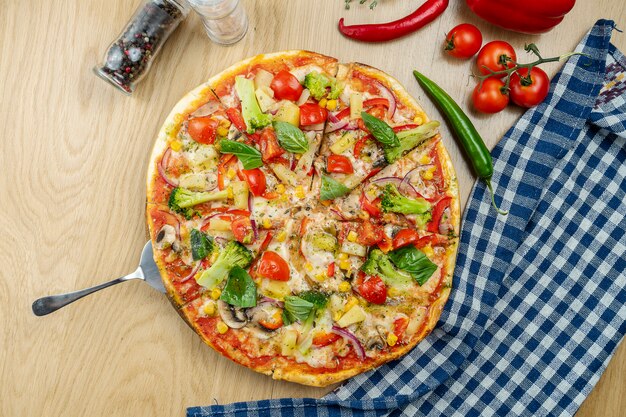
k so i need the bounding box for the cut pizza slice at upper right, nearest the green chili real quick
[315,64,439,200]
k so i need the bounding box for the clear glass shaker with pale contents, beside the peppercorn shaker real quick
[187,0,248,45]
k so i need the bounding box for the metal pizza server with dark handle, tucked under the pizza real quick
[32,242,165,316]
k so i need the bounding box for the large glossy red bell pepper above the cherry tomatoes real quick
[466,0,576,34]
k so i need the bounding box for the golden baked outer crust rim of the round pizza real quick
[146,50,460,387]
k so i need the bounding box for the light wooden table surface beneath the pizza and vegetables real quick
[0,0,626,417]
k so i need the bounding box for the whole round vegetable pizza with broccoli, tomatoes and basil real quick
[146,51,460,386]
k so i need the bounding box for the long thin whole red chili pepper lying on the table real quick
[339,0,448,42]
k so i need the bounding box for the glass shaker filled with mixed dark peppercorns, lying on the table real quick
[94,0,189,94]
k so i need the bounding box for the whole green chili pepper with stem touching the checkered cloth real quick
[413,71,509,215]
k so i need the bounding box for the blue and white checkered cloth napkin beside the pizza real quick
[187,20,626,417]
